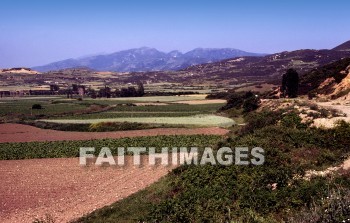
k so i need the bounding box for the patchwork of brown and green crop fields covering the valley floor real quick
[0,95,234,222]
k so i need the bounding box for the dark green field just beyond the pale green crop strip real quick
[0,95,223,119]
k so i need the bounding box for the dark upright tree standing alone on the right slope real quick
[281,68,299,98]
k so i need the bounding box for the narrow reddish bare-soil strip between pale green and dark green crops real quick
[0,124,228,142]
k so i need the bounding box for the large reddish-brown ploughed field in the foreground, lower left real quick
[0,156,173,223]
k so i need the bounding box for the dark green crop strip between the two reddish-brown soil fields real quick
[0,135,223,160]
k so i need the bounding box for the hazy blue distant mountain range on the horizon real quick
[32,47,266,72]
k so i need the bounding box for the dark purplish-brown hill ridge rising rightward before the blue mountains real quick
[104,41,350,86]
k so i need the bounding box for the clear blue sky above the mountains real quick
[0,0,350,68]
